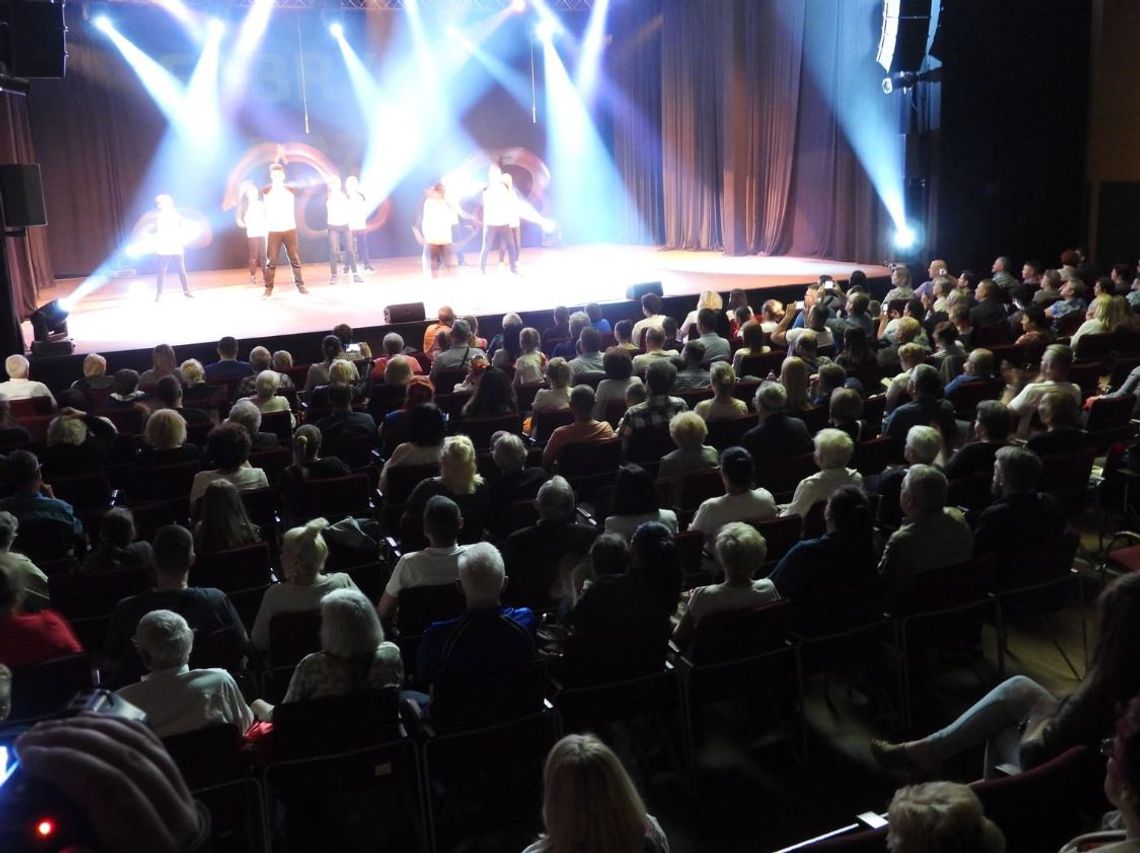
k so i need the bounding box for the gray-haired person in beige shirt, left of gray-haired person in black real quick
[879,465,974,583]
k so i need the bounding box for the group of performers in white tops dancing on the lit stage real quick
[145,162,522,302]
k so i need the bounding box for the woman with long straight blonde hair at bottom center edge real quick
[523,734,669,853]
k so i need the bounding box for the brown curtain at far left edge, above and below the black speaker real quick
[0,95,54,319]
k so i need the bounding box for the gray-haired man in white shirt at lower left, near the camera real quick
[116,610,253,738]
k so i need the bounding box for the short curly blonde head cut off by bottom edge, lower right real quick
[887,782,1005,853]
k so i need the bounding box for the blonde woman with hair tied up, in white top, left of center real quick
[252,518,359,651]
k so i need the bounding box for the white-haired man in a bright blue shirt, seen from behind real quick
[416,542,538,687]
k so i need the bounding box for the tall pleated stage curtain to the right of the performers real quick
[609,0,902,261]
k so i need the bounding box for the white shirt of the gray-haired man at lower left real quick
[115,665,253,738]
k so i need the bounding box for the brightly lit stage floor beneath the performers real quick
[33,245,889,352]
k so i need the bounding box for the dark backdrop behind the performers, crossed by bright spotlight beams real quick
[29,5,554,276]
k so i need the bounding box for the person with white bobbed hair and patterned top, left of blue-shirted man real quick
[253,590,404,720]
